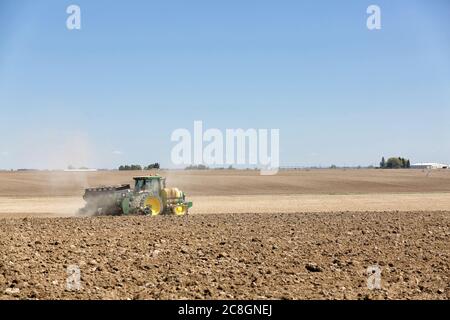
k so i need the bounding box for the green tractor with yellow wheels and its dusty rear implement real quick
[80,175,192,216]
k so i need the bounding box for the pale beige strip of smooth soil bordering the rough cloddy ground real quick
[0,193,450,218]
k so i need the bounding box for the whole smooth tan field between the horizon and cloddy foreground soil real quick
[0,169,450,217]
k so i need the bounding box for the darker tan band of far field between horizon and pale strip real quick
[0,169,450,197]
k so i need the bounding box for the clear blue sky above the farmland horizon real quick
[0,0,450,169]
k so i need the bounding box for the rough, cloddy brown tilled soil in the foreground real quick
[0,212,450,299]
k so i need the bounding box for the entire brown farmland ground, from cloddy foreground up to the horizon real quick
[0,170,450,299]
